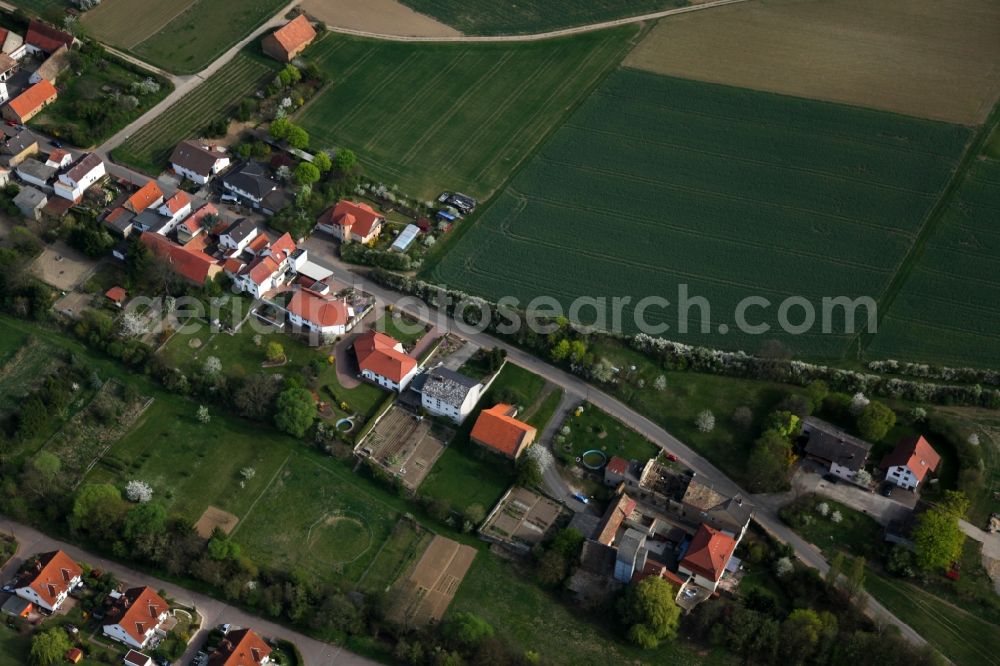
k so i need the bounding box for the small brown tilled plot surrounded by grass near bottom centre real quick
[389,536,476,627]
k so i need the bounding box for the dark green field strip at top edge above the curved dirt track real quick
[394,0,688,35]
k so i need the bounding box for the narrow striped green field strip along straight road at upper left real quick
[112,52,277,175]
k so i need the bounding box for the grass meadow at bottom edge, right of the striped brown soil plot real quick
[445,550,737,666]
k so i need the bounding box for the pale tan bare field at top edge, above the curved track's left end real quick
[299,0,462,37]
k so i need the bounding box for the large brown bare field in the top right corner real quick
[625,0,1000,125]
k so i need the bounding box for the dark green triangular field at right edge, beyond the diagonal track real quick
[868,153,1000,368]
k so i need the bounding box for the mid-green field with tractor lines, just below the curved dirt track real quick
[296,27,637,198]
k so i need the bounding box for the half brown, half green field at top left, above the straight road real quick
[82,0,287,74]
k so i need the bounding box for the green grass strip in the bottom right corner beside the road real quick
[865,569,1000,666]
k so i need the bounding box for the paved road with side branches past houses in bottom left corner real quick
[0,517,378,666]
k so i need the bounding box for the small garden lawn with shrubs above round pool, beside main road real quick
[556,396,660,464]
